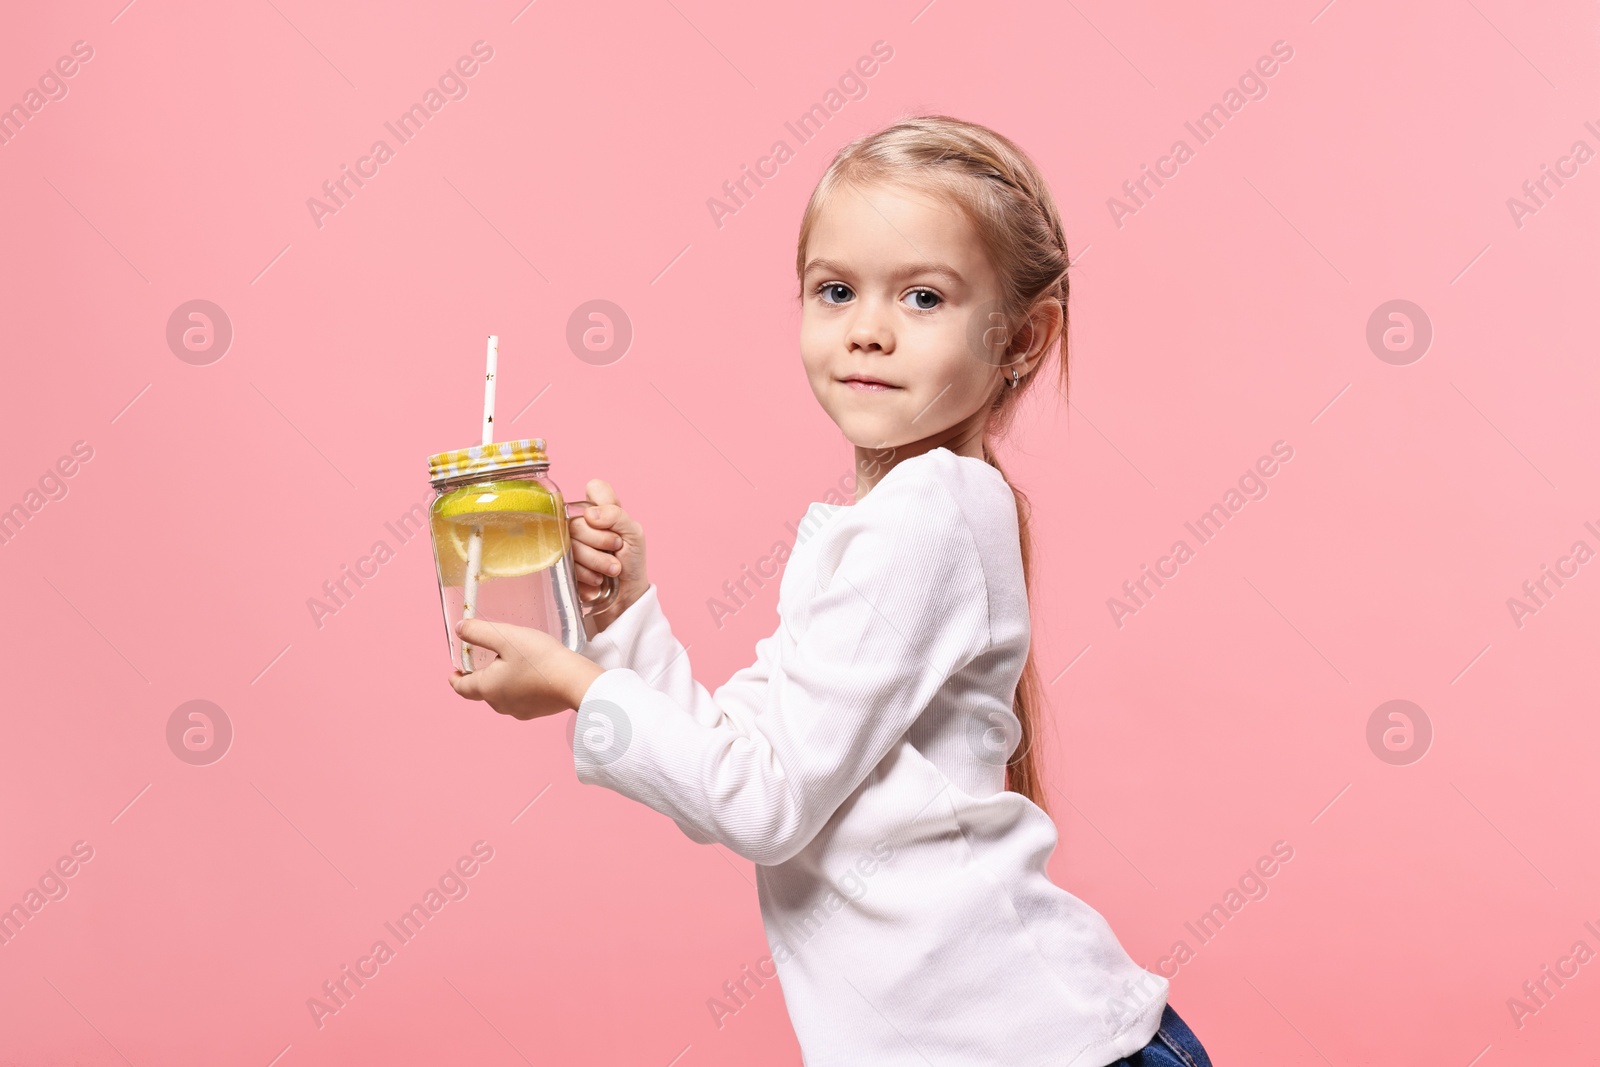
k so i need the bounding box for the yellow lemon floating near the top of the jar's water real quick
[434,483,566,585]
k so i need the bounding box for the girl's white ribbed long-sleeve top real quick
[573,448,1168,1067]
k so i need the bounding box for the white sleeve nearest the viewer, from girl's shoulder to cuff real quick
[573,480,990,865]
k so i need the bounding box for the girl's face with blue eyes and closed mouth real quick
[800,182,1004,451]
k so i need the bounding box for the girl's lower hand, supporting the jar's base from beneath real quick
[450,619,605,718]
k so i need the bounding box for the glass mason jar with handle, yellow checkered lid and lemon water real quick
[427,437,618,673]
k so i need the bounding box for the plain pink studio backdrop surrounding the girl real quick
[0,0,1600,1067]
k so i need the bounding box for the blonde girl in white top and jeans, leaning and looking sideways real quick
[451,117,1210,1067]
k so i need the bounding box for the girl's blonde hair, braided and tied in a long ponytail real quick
[795,115,1069,811]
